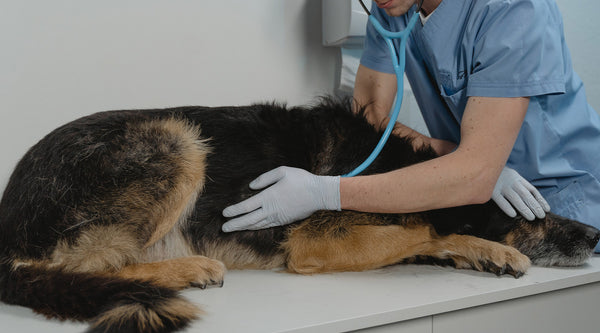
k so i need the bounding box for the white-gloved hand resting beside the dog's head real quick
[492,167,550,221]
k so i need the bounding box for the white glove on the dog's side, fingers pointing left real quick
[223,167,340,232]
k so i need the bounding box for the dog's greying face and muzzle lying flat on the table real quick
[504,213,600,266]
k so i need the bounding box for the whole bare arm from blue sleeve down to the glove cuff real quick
[340,97,529,213]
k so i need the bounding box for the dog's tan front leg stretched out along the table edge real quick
[282,212,530,277]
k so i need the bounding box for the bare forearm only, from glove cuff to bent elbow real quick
[340,148,500,213]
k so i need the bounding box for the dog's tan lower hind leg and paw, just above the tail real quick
[50,225,225,290]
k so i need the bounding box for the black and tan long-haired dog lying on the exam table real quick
[0,100,600,332]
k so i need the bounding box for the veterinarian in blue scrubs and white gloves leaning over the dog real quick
[223,0,600,251]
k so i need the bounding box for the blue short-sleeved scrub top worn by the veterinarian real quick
[361,0,600,252]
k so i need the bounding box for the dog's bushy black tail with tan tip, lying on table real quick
[0,259,200,333]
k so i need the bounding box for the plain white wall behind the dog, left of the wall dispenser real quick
[0,0,338,191]
